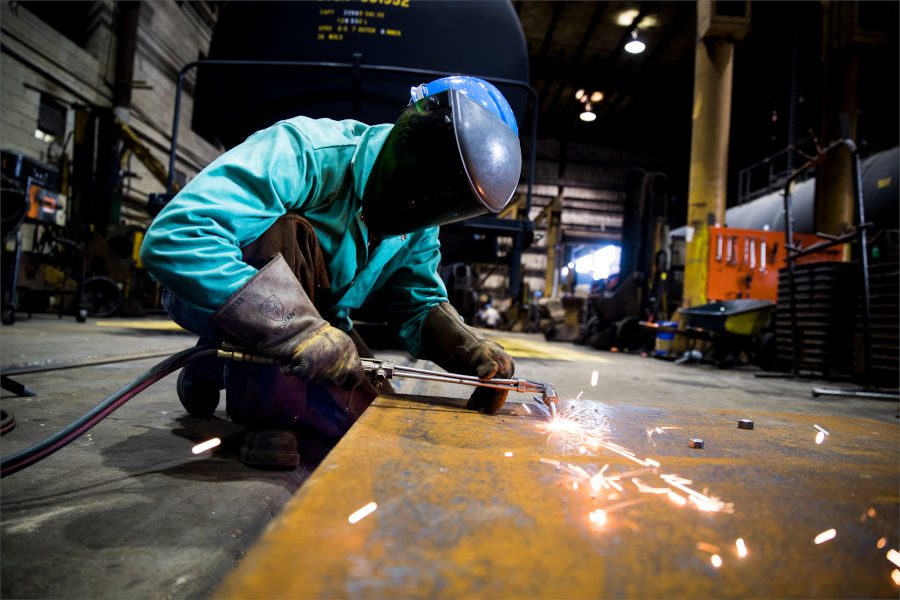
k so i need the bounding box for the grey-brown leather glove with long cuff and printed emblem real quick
[212,254,364,390]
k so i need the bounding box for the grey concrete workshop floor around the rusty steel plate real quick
[0,316,897,598]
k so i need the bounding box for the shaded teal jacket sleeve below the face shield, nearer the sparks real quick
[385,227,449,358]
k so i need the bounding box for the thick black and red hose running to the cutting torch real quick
[0,346,217,477]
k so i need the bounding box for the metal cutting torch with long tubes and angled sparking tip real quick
[218,345,559,419]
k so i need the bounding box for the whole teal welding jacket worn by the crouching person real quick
[141,117,447,356]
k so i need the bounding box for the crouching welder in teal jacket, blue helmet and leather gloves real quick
[141,76,521,468]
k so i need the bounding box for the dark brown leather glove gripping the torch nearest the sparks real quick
[422,303,515,415]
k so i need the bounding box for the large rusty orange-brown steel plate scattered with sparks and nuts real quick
[216,397,900,598]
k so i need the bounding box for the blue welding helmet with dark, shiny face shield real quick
[363,78,522,235]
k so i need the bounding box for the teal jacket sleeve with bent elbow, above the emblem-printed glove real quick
[141,123,319,314]
